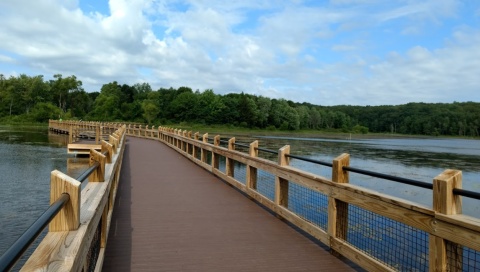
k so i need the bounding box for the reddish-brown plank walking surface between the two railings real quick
[103,137,360,271]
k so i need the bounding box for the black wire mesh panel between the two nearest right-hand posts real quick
[337,204,429,271]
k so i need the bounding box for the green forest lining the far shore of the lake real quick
[0,74,480,137]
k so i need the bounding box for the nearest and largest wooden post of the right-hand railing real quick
[429,169,463,272]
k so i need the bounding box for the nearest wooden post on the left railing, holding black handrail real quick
[48,170,82,232]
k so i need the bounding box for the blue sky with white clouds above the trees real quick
[0,0,480,105]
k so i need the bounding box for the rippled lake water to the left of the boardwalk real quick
[0,126,88,270]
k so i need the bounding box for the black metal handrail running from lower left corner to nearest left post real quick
[0,193,70,272]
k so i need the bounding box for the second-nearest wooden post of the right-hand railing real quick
[327,153,350,256]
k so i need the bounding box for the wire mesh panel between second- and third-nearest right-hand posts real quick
[288,184,328,231]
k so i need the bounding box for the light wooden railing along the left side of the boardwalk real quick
[21,121,126,271]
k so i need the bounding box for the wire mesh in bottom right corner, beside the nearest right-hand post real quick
[445,241,480,272]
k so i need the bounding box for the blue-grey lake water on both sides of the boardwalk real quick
[0,126,480,271]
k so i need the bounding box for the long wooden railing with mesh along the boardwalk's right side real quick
[126,126,480,271]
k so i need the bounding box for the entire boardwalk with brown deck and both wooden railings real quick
[0,121,480,271]
